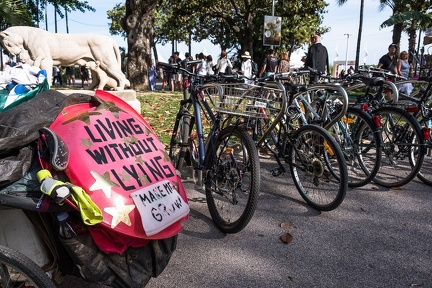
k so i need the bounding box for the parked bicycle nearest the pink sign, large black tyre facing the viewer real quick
[159,61,260,233]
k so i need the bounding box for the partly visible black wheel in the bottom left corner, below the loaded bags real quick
[0,246,55,288]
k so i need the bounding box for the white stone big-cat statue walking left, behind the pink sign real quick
[0,26,130,90]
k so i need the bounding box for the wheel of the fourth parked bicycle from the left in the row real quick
[372,107,425,187]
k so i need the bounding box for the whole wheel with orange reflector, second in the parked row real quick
[288,124,348,211]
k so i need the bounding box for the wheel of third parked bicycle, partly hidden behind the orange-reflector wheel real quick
[338,107,382,187]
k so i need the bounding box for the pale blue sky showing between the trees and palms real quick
[4,0,422,64]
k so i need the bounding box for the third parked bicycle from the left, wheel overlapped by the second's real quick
[276,68,381,187]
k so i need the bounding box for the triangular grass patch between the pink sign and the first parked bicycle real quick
[137,91,183,146]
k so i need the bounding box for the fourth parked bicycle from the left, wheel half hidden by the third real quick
[347,71,425,187]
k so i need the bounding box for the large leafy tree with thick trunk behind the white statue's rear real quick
[110,0,328,89]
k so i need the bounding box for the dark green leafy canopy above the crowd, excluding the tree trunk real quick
[108,0,330,59]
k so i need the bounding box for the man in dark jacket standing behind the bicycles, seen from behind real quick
[305,35,330,82]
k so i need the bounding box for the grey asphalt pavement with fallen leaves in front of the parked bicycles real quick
[147,158,432,288]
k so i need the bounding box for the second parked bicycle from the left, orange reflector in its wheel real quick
[230,76,348,211]
